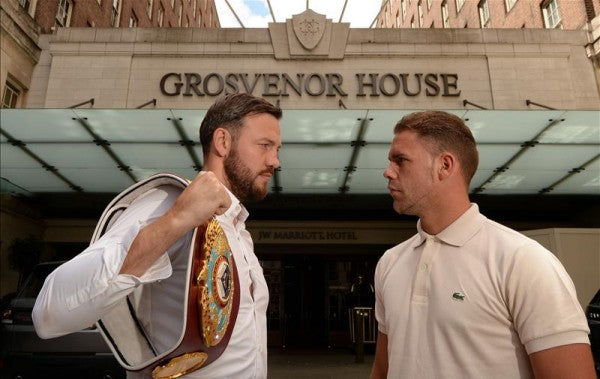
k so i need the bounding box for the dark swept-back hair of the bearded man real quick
[200,93,281,157]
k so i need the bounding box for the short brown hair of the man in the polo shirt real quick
[394,111,479,186]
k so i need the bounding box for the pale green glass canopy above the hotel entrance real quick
[0,109,600,195]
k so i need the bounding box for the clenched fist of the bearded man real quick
[168,171,231,232]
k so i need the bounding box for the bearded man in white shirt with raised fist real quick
[33,94,282,378]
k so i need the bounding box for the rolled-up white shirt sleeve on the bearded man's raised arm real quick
[32,187,181,338]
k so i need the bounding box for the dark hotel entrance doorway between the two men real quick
[257,246,385,348]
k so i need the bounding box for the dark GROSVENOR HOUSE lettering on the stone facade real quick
[159,72,461,97]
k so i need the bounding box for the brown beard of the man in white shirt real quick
[224,149,274,203]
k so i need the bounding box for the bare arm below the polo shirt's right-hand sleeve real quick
[529,343,596,379]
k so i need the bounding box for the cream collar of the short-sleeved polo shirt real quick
[417,203,485,247]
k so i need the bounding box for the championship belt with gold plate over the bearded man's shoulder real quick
[91,173,240,379]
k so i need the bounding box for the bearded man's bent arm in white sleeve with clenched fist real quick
[32,173,231,338]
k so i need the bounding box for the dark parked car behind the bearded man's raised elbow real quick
[0,262,125,379]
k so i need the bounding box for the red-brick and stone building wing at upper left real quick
[0,0,219,108]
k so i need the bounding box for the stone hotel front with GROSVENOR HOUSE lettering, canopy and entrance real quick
[0,6,600,346]
